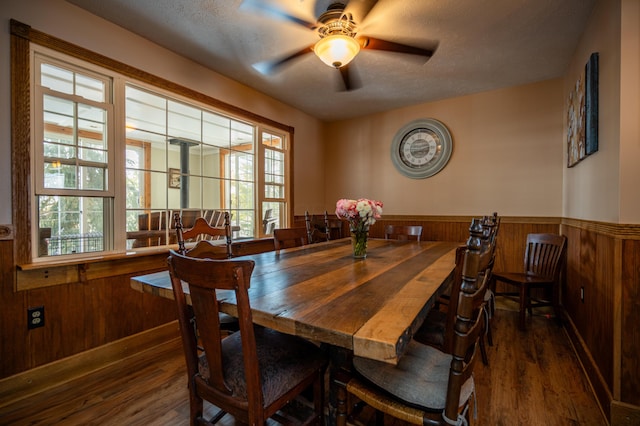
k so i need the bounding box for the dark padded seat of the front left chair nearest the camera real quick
[199,326,327,406]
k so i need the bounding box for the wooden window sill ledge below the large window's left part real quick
[15,246,169,291]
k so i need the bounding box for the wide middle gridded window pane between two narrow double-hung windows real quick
[125,84,270,248]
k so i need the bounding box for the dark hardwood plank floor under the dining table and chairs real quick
[0,310,607,426]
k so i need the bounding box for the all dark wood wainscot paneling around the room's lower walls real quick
[0,216,640,424]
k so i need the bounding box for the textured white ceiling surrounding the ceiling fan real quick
[67,0,595,121]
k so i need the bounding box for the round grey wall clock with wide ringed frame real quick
[391,118,453,179]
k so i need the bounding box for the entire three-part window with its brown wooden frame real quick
[12,25,293,264]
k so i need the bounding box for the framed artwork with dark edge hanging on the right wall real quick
[567,53,598,167]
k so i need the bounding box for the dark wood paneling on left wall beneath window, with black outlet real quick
[0,240,177,378]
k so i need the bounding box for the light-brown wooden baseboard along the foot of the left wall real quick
[0,321,180,407]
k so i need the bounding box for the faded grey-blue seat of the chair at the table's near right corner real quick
[353,340,474,411]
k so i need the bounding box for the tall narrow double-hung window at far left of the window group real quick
[34,55,113,256]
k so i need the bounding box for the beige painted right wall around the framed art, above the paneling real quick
[563,0,640,224]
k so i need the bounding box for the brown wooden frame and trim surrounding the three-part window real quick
[10,19,294,265]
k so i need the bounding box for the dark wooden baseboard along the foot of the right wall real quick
[563,311,613,421]
